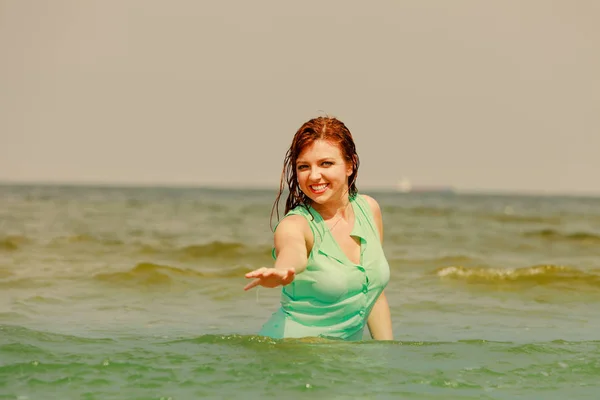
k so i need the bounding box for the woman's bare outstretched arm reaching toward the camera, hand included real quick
[244,215,310,290]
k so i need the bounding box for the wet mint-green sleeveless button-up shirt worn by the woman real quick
[259,195,390,340]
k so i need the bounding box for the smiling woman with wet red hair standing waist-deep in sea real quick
[244,117,393,340]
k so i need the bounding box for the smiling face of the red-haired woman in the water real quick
[296,140,352,205]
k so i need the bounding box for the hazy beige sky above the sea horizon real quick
[0,0,600,193]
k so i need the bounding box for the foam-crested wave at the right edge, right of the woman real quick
[435,265,600,289]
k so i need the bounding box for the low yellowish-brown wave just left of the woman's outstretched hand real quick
[94,262,250,286]
